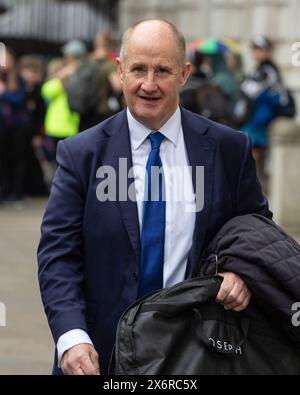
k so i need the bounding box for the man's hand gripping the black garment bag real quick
[216,273,251,312]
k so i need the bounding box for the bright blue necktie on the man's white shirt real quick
[138,132,166,298]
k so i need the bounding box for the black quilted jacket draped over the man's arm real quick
[194,214,300,342]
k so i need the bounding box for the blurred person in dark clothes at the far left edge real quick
[0,48,30,207]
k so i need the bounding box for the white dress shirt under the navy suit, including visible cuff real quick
[57,107,195,363]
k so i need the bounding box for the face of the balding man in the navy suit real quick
[117,26,190,130]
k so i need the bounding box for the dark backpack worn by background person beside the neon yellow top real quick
[66,61,100,115]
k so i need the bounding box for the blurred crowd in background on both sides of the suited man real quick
[0,32,296,207]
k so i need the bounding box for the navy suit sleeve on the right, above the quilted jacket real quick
[236,134,273,219]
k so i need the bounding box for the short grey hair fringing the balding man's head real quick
[120,19,186,64]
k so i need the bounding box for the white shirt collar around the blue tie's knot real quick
[127,107,182,151]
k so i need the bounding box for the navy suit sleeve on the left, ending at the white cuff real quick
[38,142,87,343]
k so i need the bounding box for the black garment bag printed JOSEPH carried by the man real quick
[110,276,300,375]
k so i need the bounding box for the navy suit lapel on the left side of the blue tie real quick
[101,110,140,257]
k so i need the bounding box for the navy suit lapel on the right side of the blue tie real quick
[181,109,216,278]
